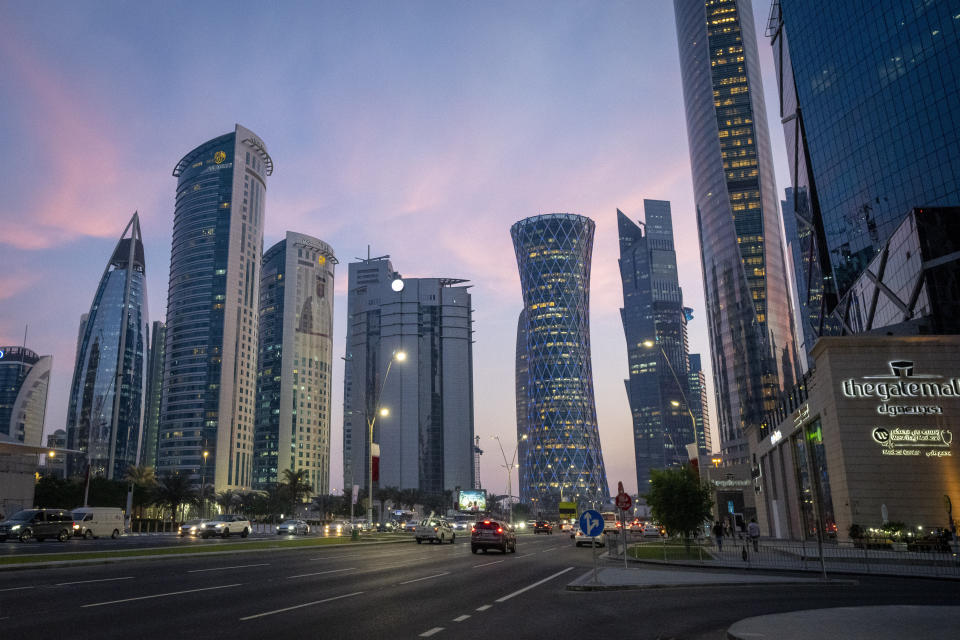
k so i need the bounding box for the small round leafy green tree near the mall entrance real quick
[644,467,713,539]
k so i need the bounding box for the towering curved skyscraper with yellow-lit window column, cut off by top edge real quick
[674,0,797,462]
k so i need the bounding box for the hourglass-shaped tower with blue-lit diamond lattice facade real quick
[510,213,610,512]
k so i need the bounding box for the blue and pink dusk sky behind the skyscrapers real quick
[0,0,789,493]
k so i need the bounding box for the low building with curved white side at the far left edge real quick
[0,346,53,444]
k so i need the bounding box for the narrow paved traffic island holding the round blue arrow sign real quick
[567,567,836,591]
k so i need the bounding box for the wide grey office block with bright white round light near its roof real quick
[343,256,474,495]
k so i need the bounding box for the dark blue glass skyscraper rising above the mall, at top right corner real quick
[767,0,960,350]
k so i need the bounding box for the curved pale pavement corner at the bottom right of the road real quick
[727,605,960,640]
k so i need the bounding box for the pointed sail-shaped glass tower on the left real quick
[67,214,150,479]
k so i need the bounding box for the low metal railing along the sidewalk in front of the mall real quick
[603,537,960,579]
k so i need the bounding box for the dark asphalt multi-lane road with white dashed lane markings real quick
[0,535,960,640]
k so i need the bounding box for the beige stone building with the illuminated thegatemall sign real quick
[750,335,960,540]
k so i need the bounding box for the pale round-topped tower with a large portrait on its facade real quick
[253,231,337,494]
